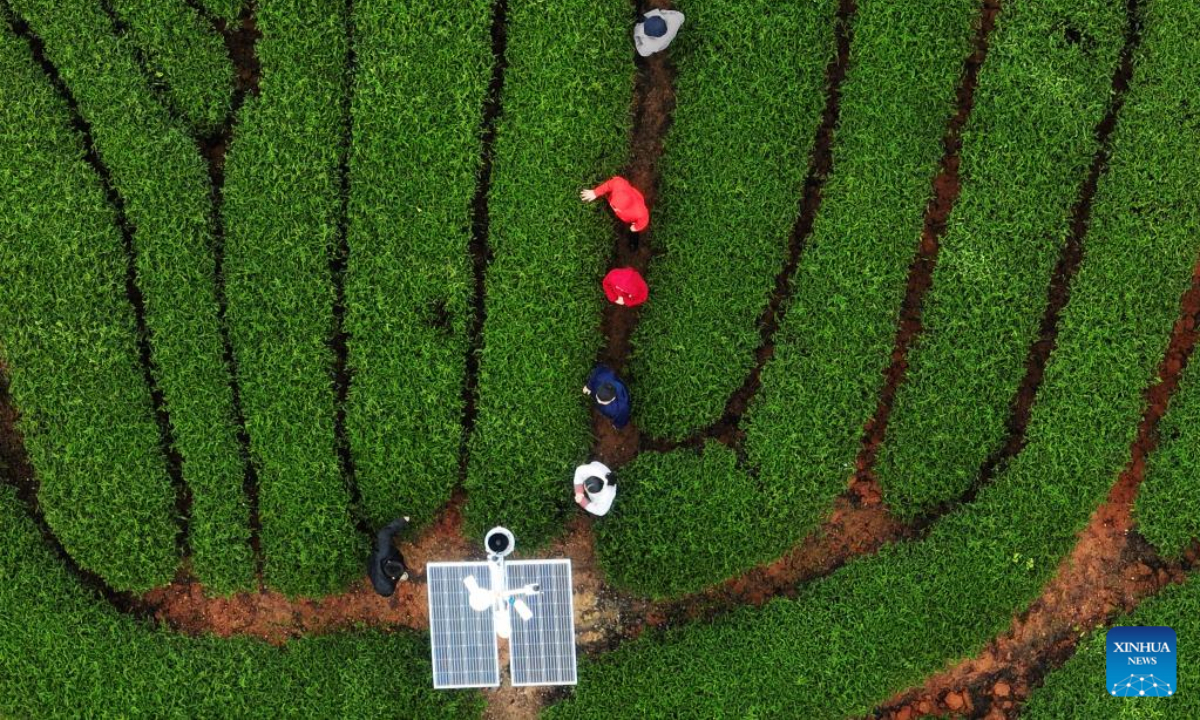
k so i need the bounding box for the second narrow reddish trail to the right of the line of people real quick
[856,0,1001,496]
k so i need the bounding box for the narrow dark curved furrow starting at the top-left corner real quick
[4,4,192,554]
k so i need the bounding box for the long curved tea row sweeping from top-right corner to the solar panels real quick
[547,0,1200,720]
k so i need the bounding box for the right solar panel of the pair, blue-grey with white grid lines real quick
[505,559,577,685]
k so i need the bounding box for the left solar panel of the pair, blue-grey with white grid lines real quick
[425,563,500,689]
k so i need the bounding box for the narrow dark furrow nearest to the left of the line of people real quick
[458,0,509,487]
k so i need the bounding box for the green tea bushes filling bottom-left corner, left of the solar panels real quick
[0,484,484,720]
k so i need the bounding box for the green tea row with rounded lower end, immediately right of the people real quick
[630,0,838,438]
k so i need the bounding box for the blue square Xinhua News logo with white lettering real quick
[1104,628,1178,697]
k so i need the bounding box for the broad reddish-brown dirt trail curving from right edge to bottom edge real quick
[875,252,1200,720]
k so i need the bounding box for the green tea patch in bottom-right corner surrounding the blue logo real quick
[1021,575,1200,720]
